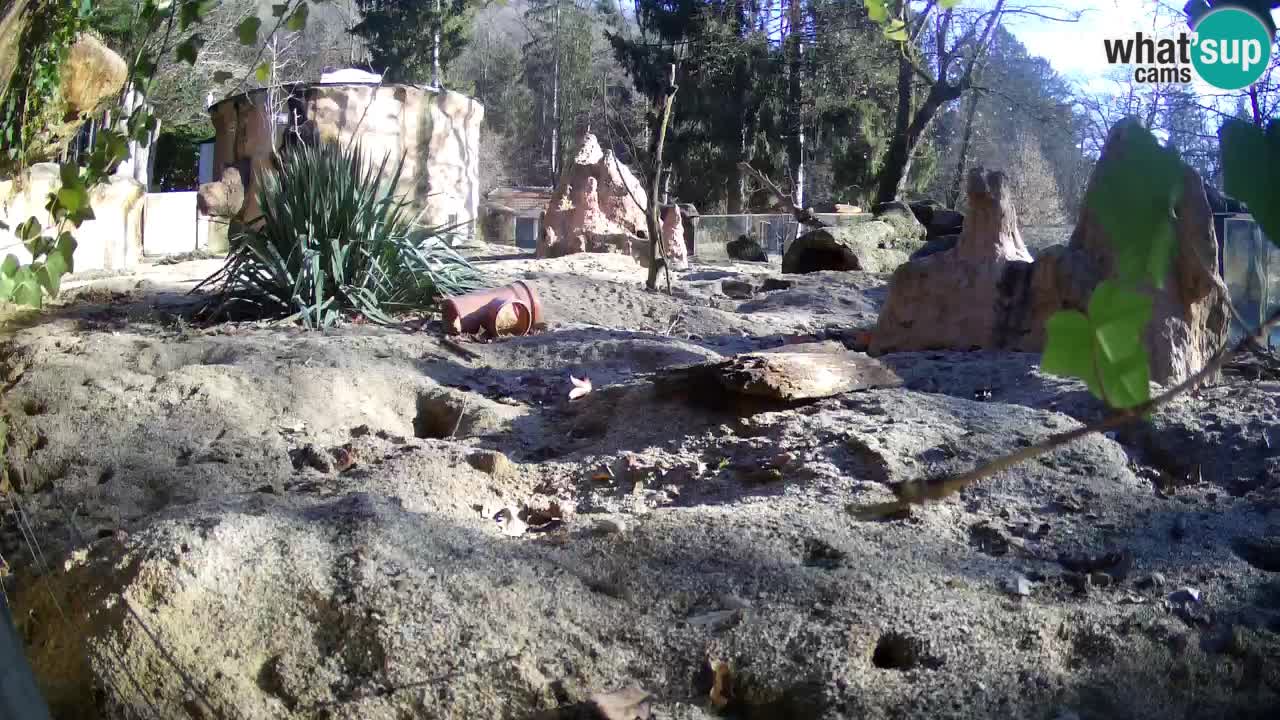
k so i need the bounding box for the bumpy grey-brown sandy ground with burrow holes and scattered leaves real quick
[0,243,1280,720]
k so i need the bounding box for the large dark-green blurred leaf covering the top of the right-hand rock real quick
[1085,126,1183,287]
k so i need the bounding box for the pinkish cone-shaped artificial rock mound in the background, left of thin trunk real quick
[538,133,648,258]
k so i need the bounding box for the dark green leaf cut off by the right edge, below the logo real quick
[1219,118,1280,245]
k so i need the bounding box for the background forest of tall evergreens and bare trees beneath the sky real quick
[87,0,1274,213]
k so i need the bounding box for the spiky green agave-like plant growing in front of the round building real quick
[196,142,481,328]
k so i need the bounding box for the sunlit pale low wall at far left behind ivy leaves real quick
[0,163,143,272]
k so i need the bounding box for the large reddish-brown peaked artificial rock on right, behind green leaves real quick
[870,120,1229,384]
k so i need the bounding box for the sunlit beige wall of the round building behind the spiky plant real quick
[209,83,484,227]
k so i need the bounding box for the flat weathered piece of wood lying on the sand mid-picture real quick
[659,342,902,402]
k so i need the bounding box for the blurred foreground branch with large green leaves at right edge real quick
[850,119,1280,519]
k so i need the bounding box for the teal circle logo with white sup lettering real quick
[1192,8,1271,90]
